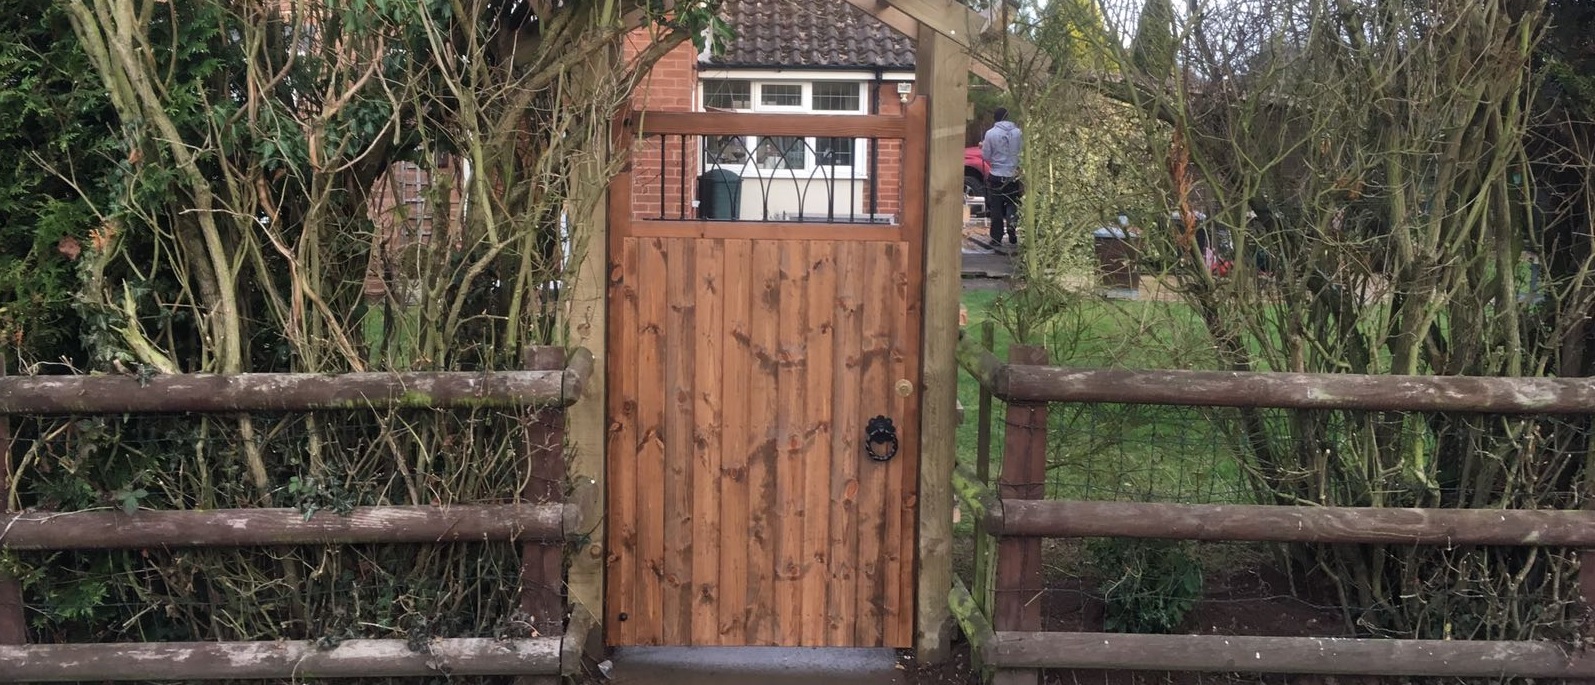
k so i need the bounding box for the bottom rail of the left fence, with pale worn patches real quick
[0,637,560,682]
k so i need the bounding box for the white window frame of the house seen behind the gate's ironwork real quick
[695,72,874,180]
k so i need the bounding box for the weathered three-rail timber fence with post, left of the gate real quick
[0,348,593,682]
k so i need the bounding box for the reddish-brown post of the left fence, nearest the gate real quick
[517,346,565,685]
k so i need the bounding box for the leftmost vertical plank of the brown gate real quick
[603,238,641,645]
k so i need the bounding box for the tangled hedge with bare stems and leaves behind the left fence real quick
[0,0,704,648]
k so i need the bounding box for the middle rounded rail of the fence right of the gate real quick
[992,500,1595,548]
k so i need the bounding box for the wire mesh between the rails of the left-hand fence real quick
[0,409,563,651]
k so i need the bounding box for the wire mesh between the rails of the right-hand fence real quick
[967,386,1595,673]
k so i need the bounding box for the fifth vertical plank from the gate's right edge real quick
[775,241,809,647]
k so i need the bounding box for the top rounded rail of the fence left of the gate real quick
[0,344,592,415]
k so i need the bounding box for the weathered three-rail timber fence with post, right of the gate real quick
[949,331,1595,685]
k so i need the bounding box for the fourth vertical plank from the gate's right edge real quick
[799,241,845,647]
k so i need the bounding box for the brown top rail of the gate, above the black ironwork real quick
[632,110,908,139]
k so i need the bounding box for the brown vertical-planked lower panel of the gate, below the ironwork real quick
[608,238,919,647]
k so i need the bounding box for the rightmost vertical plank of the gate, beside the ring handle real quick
[885,244,925,647]
